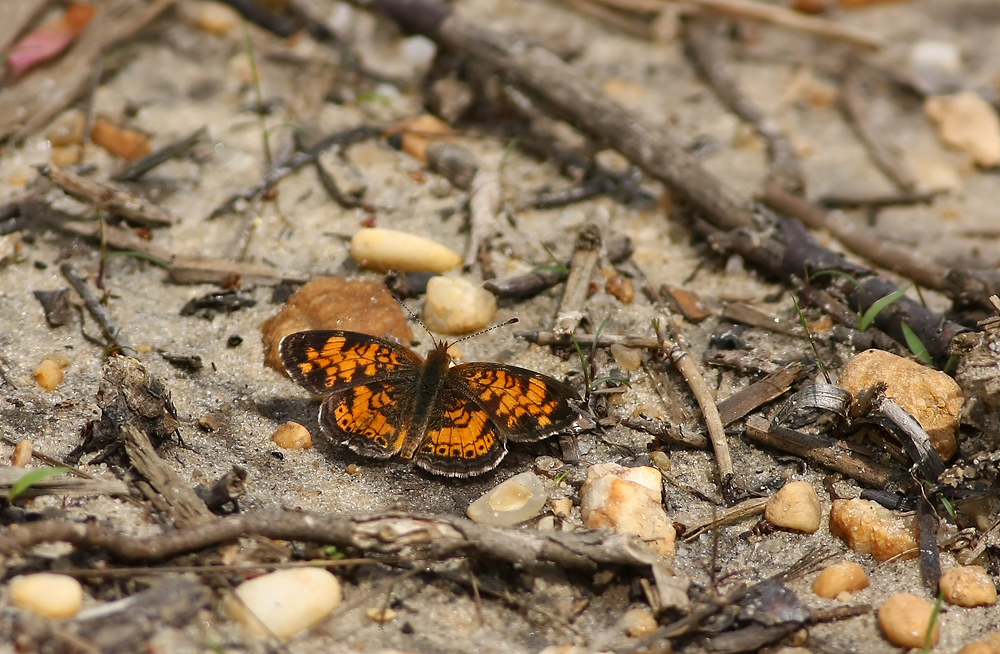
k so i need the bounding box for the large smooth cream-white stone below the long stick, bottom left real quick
[225,568,341,640]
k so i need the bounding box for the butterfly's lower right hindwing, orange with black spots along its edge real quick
[413,386,507,477]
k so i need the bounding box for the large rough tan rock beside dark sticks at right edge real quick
[837,350,964,461]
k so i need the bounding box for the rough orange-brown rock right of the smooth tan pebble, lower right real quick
[830,499,920,561]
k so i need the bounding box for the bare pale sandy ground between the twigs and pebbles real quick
[0,0,1000,653]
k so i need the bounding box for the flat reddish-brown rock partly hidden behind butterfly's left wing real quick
[260,277,413,374]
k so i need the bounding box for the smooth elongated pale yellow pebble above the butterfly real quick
[351,227,462,273]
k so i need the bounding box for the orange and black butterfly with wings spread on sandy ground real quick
[279,330,578,477]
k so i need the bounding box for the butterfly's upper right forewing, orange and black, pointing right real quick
[447,363,579,441]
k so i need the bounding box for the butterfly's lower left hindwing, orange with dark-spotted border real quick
[319,380,414,459]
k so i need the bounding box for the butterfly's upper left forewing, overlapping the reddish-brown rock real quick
[278,330,423,396]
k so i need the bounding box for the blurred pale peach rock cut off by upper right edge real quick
[924,91,1000,168]
